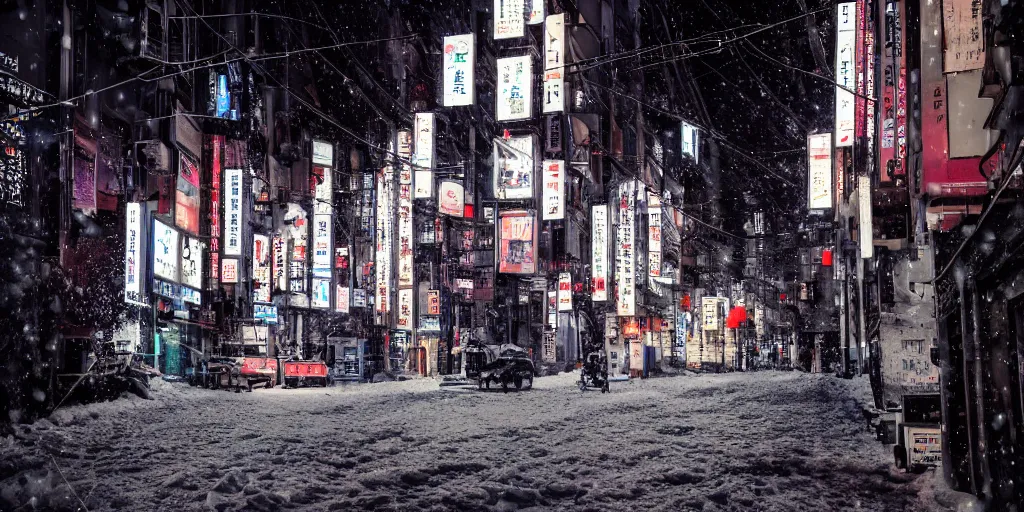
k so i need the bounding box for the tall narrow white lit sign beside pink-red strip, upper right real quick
[829,2,857,148]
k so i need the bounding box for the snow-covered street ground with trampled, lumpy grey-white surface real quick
[0,373,954,511]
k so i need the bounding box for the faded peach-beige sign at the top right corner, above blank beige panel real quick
[942,0,985,73]
